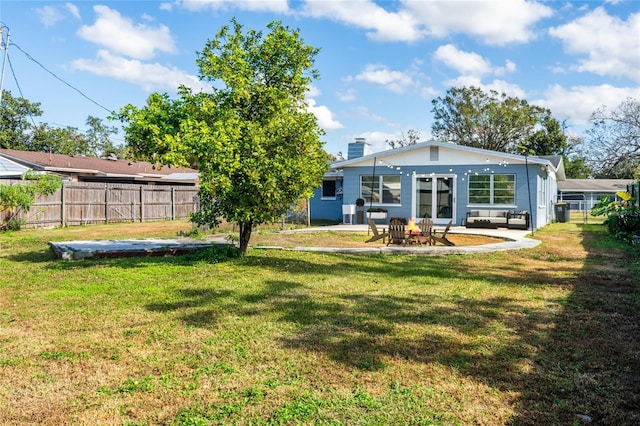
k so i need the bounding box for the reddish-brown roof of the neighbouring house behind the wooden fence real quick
[0,149,198,181]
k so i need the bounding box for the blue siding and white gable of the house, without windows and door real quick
[312,142,564,227]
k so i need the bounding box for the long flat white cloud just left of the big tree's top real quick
[71,50,211,92]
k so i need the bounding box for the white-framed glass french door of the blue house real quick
[414,175,455,224]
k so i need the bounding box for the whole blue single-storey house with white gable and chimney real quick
[310,139,565,228]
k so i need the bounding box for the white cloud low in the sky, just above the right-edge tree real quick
[532,84,640,126]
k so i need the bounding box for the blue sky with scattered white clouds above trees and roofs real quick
[0,0,640,154]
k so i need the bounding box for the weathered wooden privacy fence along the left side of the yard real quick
[0,179,198,228]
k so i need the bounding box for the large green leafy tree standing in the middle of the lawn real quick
[118,20,328,254]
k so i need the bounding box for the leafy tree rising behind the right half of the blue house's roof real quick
[431,86,552,154]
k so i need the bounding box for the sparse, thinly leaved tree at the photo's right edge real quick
[587,98,640,179]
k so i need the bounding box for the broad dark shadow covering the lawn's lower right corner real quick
[513,225,640,425]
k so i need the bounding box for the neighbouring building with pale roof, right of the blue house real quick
[558,179,635,210]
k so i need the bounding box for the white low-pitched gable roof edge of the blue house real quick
[331,141,565,180]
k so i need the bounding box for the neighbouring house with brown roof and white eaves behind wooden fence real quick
[0,149,198,186]
